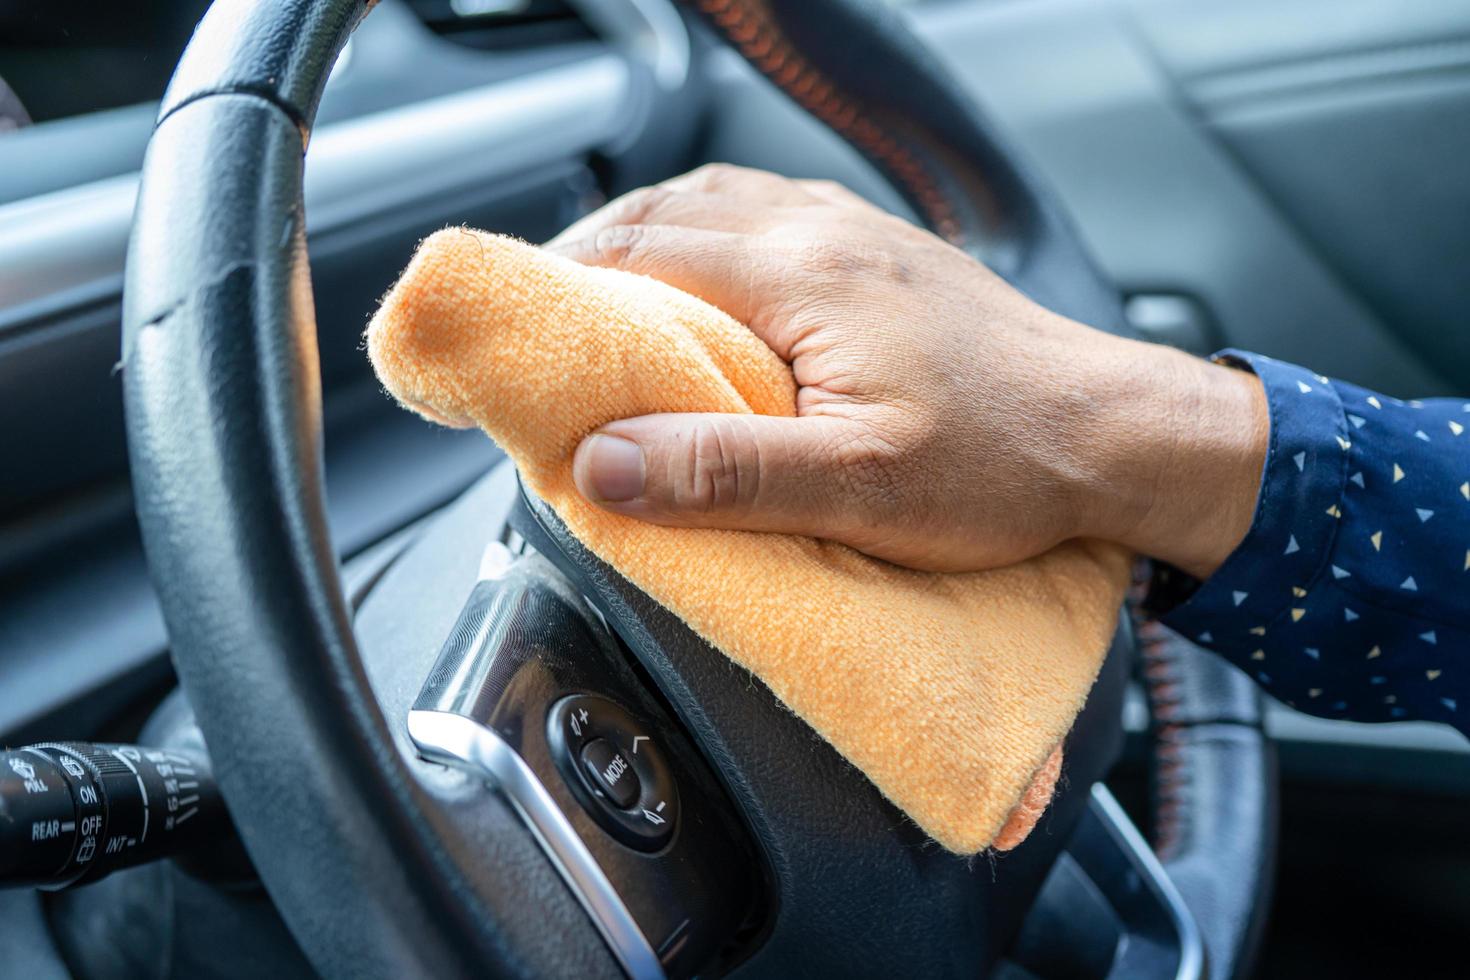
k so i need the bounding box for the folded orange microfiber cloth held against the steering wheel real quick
[368,228,1129,854]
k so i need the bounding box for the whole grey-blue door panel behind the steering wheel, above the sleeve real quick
[914,0,1470,395]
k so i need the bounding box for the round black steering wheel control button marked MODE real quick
[547,695,679,851]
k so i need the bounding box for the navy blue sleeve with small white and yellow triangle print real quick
[1161,351,1470,733]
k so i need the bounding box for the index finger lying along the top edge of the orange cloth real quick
[545,225,792,333]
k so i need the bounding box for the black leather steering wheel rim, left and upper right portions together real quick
[122,0,1275,976]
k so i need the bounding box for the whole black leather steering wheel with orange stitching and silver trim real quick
[122,0,1273,977]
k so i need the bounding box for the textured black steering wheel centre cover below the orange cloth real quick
[512,481,1129,977]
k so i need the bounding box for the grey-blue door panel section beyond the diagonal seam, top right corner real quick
[1135,0,1470,391]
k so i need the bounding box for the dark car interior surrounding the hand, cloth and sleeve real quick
[0,0,1470,980]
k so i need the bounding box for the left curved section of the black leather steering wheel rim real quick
[122,0,515,976]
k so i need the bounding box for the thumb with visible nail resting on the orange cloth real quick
[572,413,863,541]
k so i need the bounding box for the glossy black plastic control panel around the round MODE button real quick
[411,555,769,977]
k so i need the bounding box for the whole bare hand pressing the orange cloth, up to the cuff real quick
[547,166,1267,577]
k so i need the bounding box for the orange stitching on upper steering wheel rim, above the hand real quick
[694,0,964,245]
